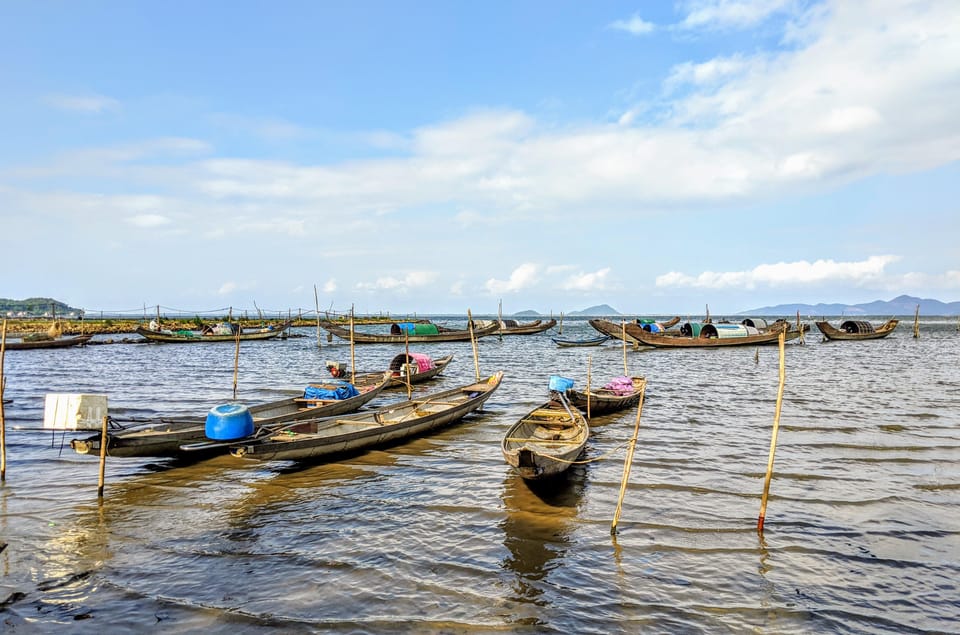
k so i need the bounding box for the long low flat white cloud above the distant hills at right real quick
[656,256,900,289]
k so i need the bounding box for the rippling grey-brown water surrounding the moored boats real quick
[0,318,960,633]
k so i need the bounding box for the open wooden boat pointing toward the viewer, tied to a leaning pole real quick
[500,392,590,480]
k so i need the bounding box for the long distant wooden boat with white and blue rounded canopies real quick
[626,322,800,348]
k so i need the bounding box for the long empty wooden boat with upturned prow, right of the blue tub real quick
[230,371,503,461]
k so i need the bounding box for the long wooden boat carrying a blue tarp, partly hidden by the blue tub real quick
[70,372,392,457]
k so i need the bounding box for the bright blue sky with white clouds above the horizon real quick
[0,0,960,315]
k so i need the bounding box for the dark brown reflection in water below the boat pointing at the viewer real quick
[500,465,586,606]
